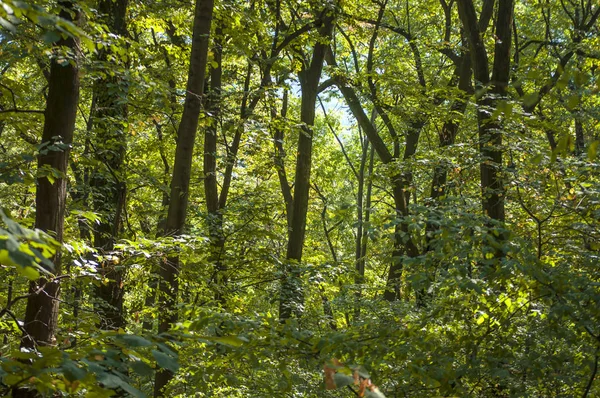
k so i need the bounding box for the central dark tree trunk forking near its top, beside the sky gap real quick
[279,15,333,321]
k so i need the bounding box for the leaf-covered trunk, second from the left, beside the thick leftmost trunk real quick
[90,0,128,330]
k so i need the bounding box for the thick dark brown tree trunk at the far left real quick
[15,1,79,352]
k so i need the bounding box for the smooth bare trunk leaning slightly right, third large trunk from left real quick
[154,0,214,397]
